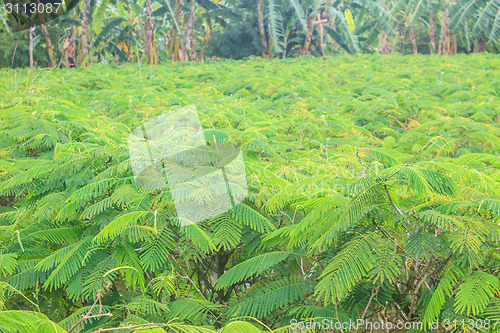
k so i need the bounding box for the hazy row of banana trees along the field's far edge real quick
[0,0,500,67]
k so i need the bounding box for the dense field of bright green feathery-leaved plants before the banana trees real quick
[0,54,500,332]
